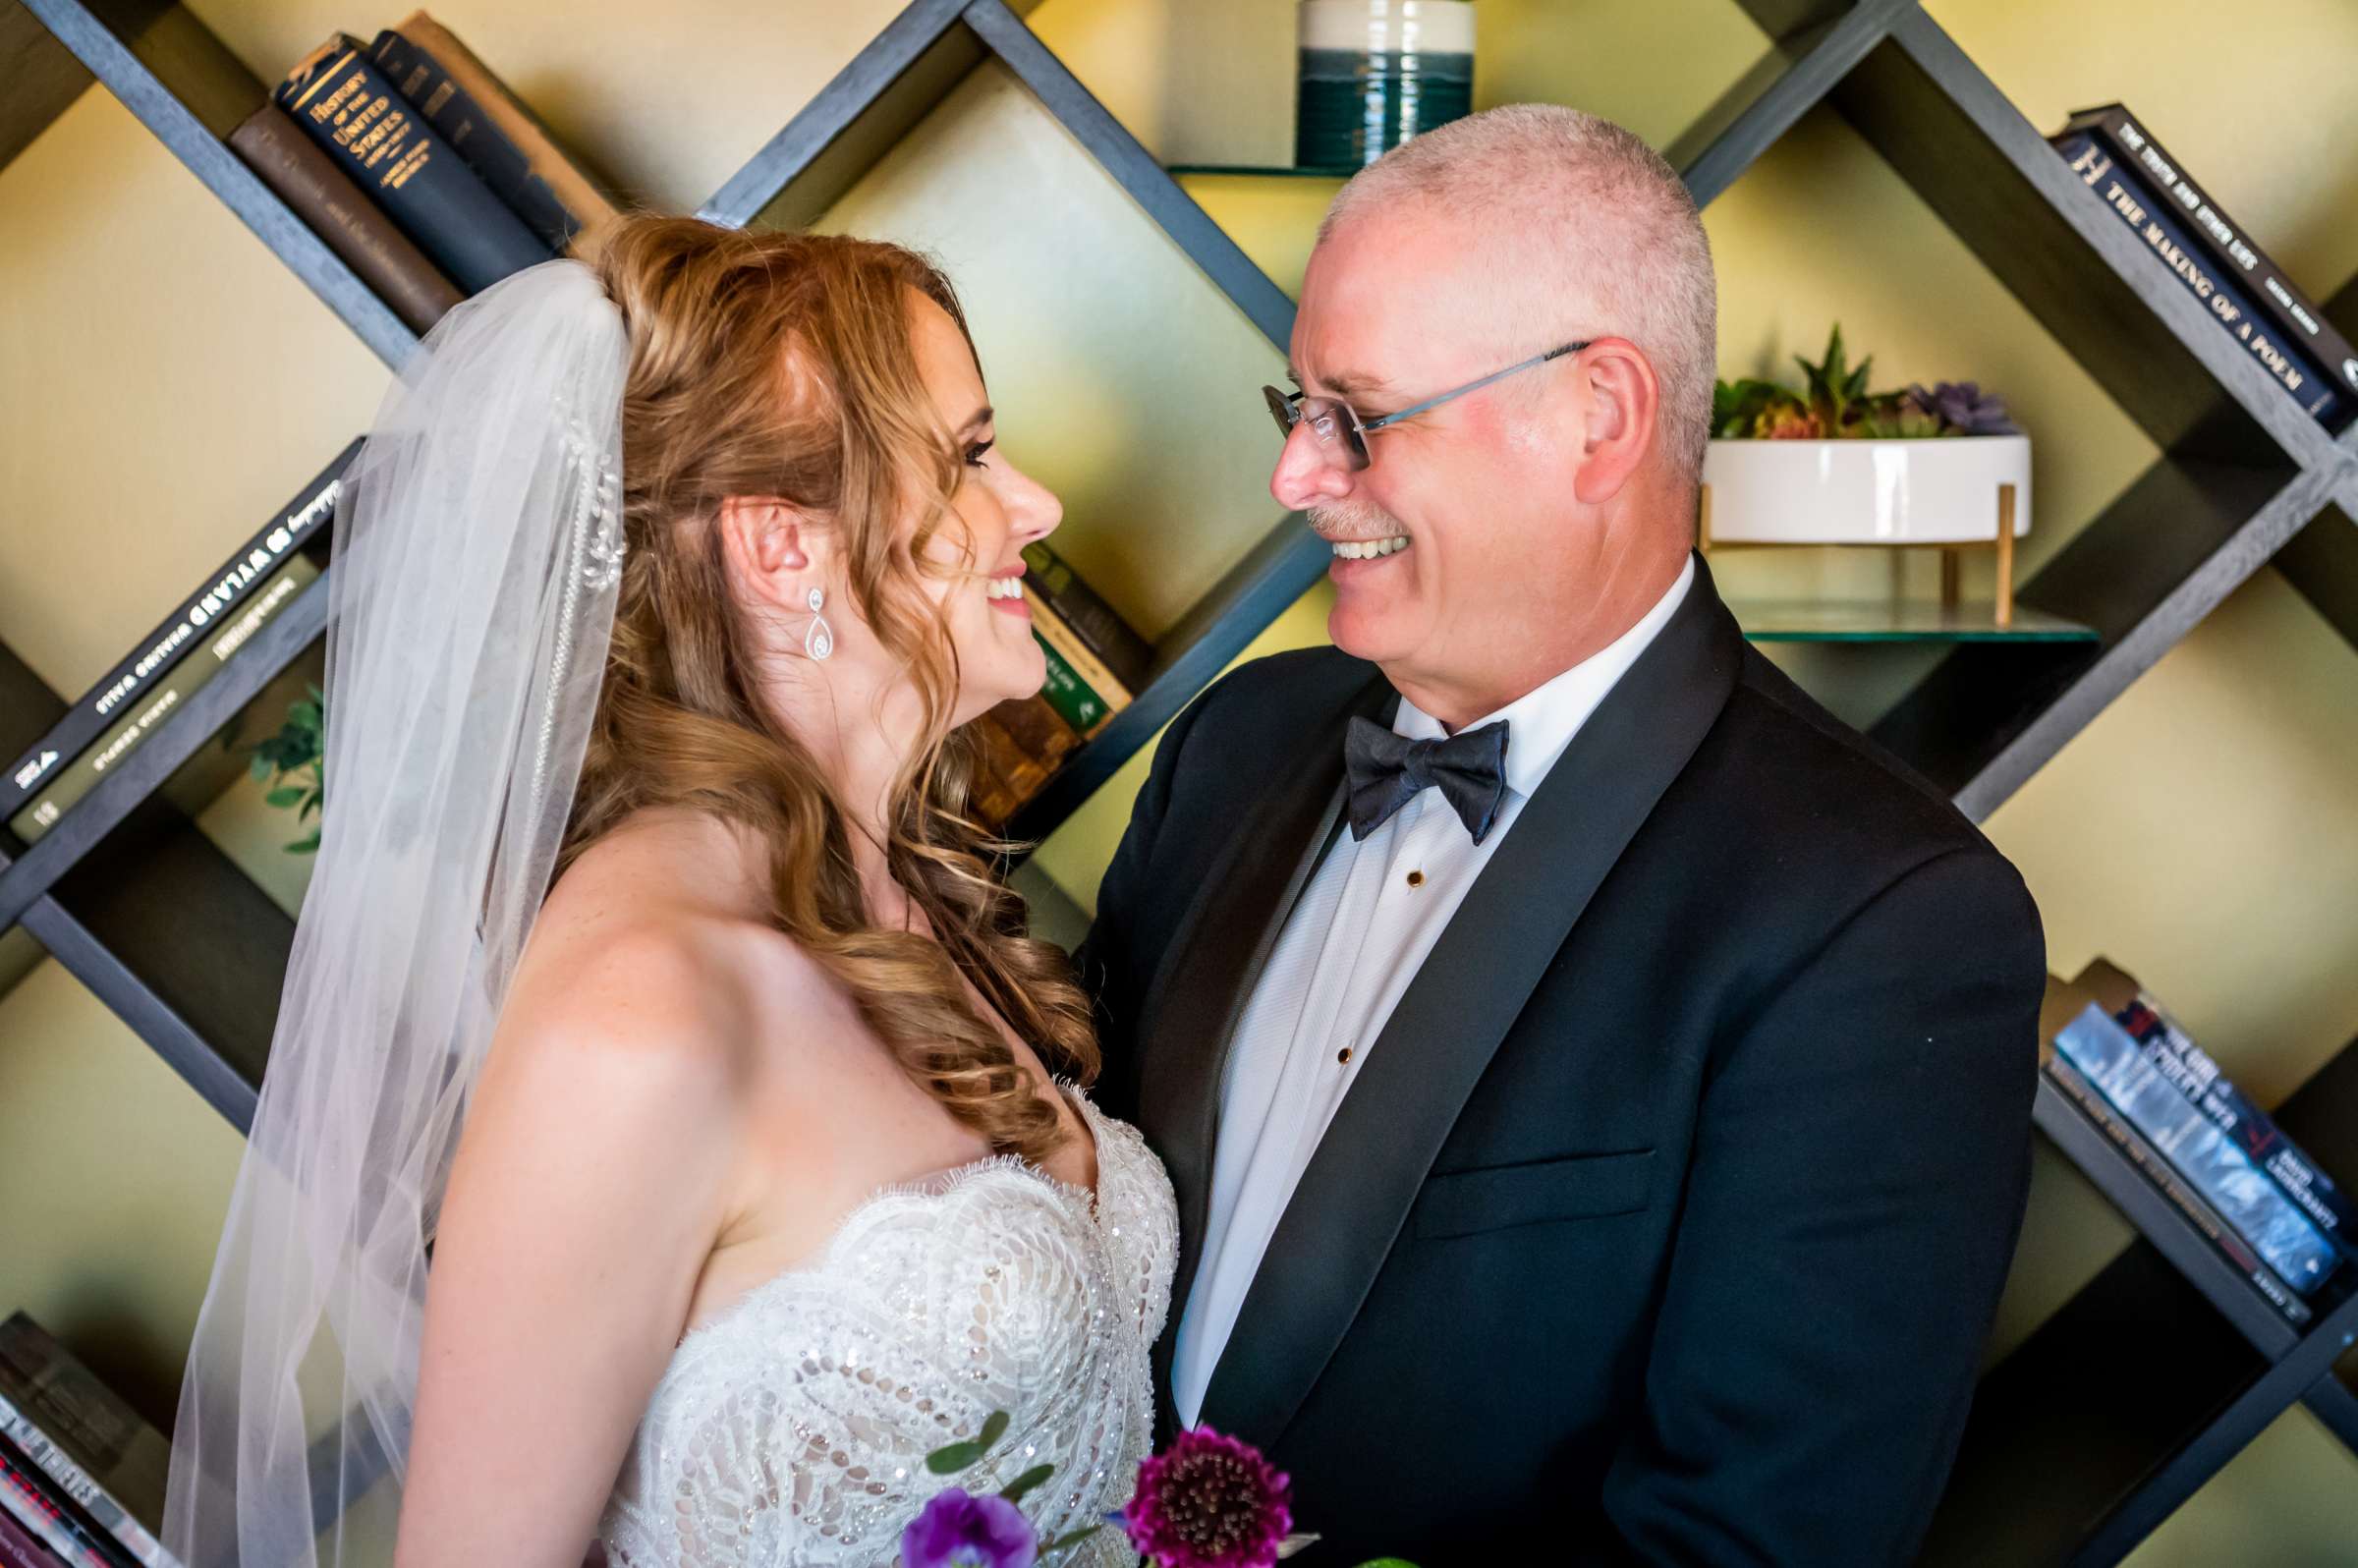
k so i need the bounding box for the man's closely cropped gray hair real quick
[1319,104,1719,478]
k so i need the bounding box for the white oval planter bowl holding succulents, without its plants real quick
[1703,436,2030,544]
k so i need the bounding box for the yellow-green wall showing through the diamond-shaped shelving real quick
[0,0,2358,1537]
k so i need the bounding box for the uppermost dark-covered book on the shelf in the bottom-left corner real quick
[0,1311,182,1568]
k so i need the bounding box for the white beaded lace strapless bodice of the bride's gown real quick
[599,1094,1179,1568]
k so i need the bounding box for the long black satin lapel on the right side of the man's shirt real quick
[1207,561,1743,1450]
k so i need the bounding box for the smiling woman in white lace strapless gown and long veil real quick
[165,217,1174,1568]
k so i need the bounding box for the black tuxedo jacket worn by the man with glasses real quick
[1083,561,2045,1568]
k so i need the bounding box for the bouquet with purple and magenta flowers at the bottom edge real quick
[901,1413,1415,1568]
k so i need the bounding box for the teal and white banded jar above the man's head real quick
[1295,0,1474,170]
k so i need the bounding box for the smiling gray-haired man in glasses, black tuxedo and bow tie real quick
[1083,106,2045,1568]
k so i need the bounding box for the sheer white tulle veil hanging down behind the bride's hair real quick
[163,261,627,1568]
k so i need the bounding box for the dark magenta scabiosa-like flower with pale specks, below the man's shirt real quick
[1122,1427,1295,1568]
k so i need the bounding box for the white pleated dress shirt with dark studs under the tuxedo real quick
[1172,556,1696,1427]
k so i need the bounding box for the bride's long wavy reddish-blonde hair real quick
[559,217,1096,1160]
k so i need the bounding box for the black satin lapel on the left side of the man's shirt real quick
[1139,677,1398,1372]
